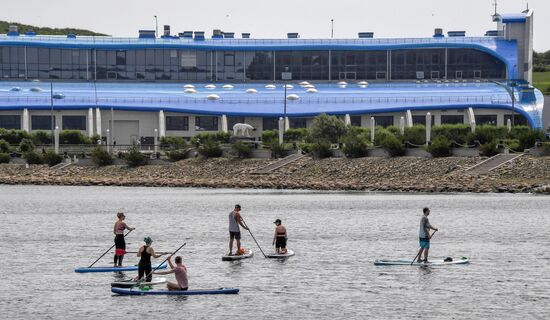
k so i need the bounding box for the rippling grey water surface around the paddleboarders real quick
[0,186,550,319]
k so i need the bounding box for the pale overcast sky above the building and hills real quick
[0,0,550,51]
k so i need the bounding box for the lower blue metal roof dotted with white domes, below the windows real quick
[0,81,543,128]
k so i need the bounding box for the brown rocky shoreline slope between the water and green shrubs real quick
[0,156,550,194]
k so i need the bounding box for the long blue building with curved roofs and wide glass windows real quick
[0,11,543,144]
